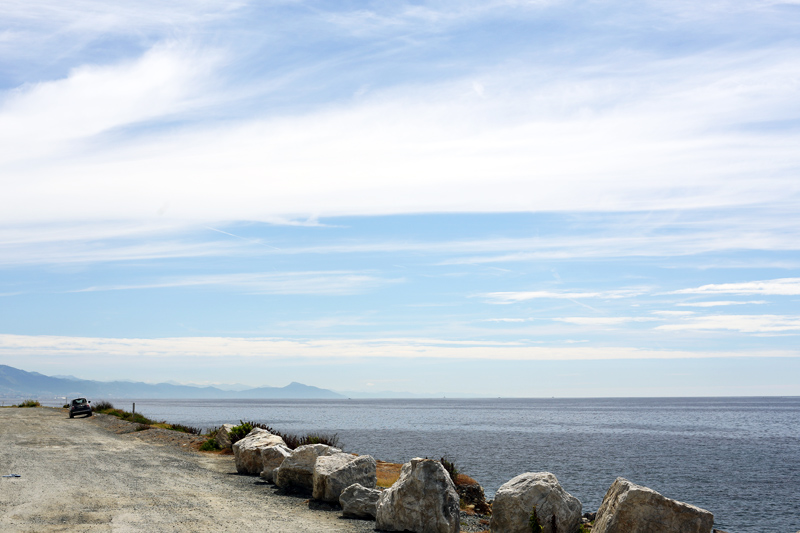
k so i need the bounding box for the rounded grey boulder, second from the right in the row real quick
[490,472,580,533]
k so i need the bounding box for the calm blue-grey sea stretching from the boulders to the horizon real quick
[51,397,800,533]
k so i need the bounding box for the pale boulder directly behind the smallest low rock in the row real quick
[312,453,378,502]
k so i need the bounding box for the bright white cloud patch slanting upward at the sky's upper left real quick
[0,43,218,163]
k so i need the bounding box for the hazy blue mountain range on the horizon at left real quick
[0,365,346,399]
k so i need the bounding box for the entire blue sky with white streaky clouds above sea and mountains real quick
[0,0,800,397]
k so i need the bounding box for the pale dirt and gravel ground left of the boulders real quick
[0,408,375,533]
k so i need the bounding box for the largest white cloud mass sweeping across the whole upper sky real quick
[0,44,800,225]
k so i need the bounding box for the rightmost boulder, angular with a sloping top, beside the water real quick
[592,477,714,533]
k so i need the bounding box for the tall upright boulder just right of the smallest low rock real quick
[375,458,461,533]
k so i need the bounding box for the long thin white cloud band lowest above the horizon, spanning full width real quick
[0,334,800,362]
